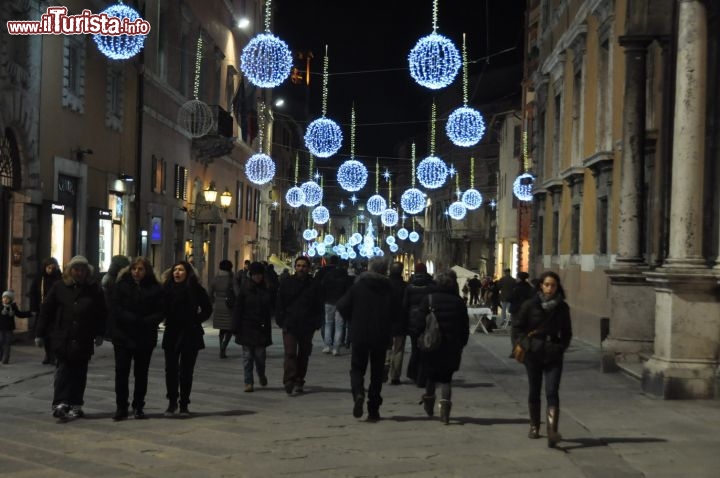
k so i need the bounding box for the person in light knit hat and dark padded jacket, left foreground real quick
[35,256,107,420]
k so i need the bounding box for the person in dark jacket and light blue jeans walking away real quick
[320,256,351,355]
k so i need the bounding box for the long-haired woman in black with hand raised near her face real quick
[162,261,212,417]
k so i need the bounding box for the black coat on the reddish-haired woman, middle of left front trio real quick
[108,267,163,349]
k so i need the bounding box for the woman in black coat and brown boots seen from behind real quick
[420,271,470,425]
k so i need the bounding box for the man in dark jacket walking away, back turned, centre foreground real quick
[337,257,400,422]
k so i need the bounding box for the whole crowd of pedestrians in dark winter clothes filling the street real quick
[14,256,572,446]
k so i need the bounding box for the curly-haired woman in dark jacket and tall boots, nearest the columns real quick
[512,271,572,448]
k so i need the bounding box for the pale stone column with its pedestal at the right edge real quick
[642,0,720,398]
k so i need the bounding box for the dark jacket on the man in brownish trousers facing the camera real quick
[275,275,325,335]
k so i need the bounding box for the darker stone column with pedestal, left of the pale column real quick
[602,35,655,372]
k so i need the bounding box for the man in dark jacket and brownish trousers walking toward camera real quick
[275,256,323,395]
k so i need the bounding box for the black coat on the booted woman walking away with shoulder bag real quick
[420,291,470,377]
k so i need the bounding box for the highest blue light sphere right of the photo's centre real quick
[408,33,462,90]
